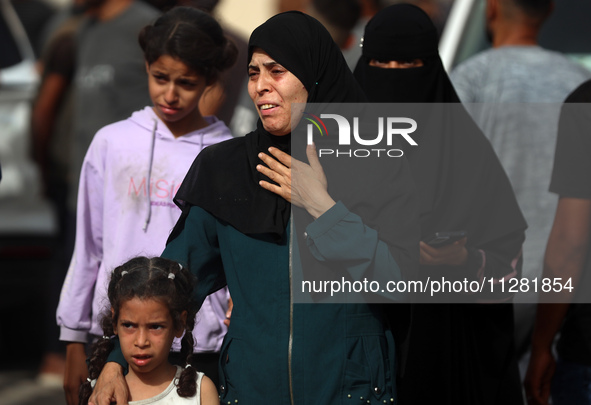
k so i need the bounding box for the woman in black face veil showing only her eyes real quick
[355,4,526,405]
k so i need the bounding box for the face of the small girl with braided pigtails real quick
[115,297,186,374]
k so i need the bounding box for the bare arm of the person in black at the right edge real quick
[524,198,591,405]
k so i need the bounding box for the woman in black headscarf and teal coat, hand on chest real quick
[88,12,419,405]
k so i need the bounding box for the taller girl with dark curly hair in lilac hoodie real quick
[57,7,237,405]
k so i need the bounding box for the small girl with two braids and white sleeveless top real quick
[80,257,219,405]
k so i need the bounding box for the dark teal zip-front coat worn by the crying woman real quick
[162,202,401,405]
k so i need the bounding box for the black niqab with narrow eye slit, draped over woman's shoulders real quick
[355,4,526,253]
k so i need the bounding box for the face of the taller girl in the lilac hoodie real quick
[146,55,207,136]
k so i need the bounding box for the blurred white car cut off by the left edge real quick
[0,0,57,236]
